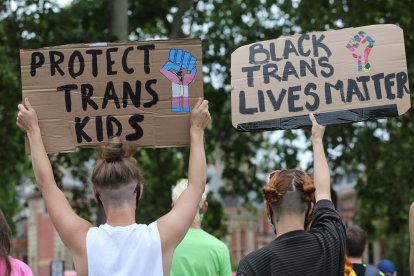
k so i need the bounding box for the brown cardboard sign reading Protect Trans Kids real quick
[20,39,203,152]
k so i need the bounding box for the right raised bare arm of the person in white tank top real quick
[157,99,210,268]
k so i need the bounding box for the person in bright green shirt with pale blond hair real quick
[171,179,231,276]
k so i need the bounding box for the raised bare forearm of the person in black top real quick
[309,113,331,201]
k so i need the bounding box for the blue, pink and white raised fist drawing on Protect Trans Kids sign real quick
[160,49,197,112]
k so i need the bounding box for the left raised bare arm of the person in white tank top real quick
[17,98,92,254]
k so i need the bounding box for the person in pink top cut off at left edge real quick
[0,210,33,276]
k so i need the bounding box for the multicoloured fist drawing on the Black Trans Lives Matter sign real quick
[346,31,375,72]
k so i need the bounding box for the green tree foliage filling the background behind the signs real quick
[0,0,414,275]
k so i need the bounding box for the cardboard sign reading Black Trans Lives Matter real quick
[231,25,411,131]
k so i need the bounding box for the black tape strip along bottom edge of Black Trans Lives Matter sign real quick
[237,104,398,131]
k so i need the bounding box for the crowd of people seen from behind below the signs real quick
[0,98,414,276]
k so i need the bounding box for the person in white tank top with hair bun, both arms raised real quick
[17,98,210,276]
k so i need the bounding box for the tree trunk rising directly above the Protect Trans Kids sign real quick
[109,0,128,41]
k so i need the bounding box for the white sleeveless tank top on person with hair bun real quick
[86,222,163,276]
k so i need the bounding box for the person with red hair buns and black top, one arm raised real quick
[237,114,346,276]
